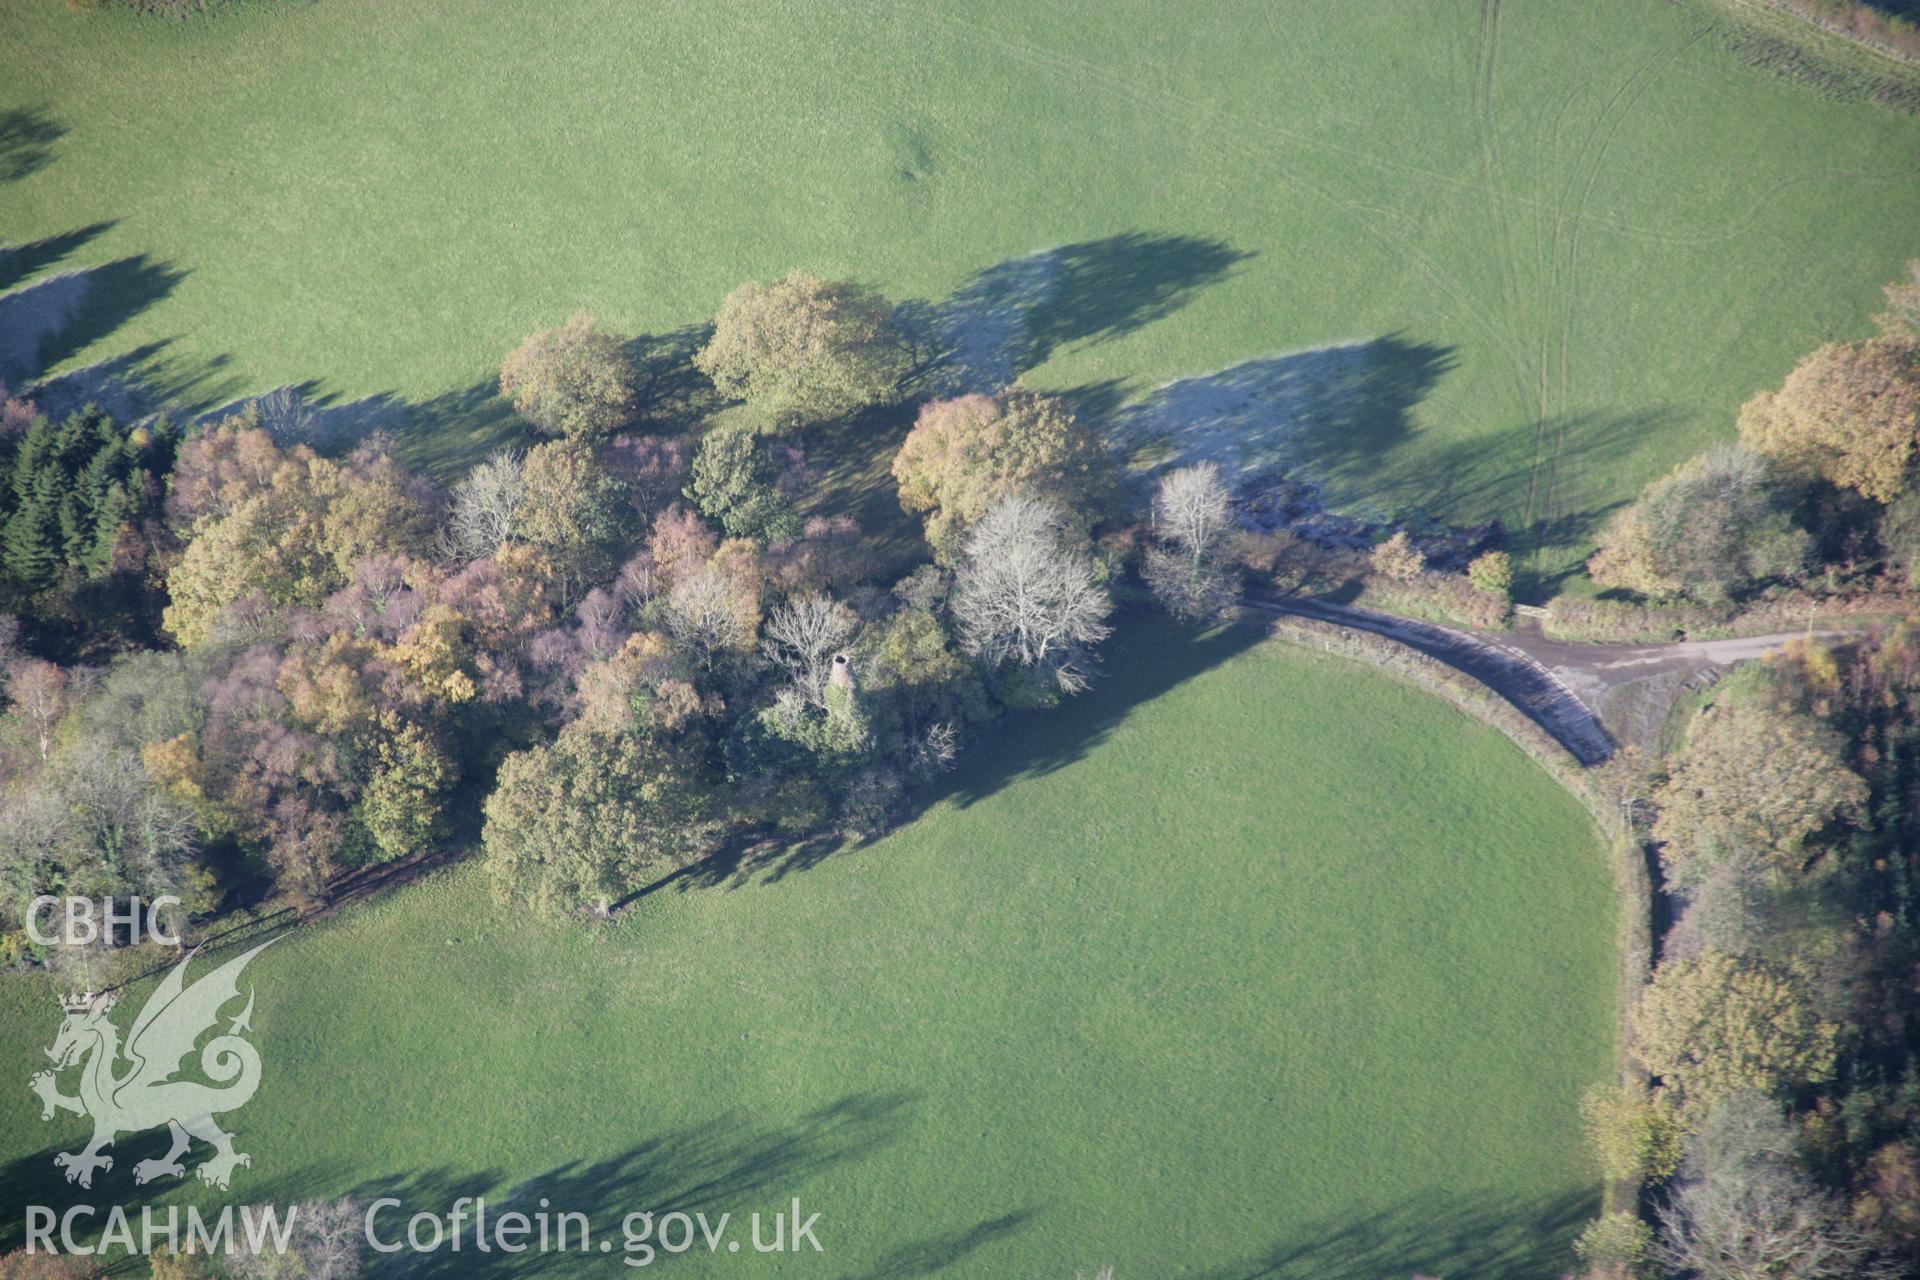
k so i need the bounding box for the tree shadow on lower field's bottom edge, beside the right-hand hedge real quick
[1206,1194,1599,1280]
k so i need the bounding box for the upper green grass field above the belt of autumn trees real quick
[0,0,1920,595]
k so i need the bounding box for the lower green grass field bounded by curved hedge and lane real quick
[0,618,1619,1280]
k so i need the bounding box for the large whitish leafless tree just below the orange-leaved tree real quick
[952,493,1114,693]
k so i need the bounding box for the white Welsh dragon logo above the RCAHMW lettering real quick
[29,938,278,1190]
